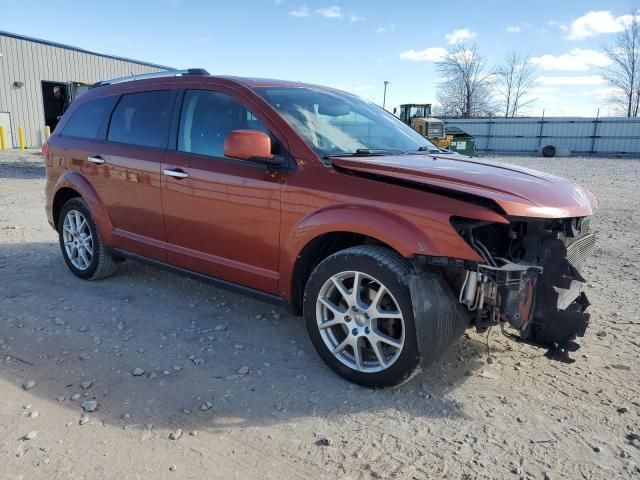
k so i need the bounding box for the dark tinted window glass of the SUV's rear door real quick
[107,90,173,148]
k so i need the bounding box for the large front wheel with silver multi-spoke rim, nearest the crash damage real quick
[303,246,421,388]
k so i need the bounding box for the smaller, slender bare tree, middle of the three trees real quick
[495,50,537,118]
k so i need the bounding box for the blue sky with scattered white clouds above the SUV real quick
[0,0,640,116]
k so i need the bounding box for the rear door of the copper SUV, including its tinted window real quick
[88,90,176,261]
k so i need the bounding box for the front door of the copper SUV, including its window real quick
[162,89,286,293]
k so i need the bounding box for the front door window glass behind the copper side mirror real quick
[178,90,269,157]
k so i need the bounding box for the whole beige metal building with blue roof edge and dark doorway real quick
[0,31,171,148]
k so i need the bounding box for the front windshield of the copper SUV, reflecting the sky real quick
[256,87,438,156]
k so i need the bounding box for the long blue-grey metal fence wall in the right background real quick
[445,117,640,157]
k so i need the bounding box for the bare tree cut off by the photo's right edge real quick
[602,10,640,117]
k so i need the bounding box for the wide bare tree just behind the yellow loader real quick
[436,44,494,118]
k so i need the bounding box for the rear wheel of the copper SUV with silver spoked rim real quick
[57,197,117,280]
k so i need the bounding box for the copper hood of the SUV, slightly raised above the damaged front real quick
[331,154,598,218]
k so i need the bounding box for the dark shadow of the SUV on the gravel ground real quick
[0,243,485,429]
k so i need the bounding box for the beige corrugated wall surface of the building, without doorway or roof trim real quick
[0,33,169,146]
